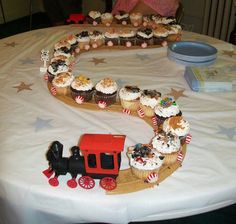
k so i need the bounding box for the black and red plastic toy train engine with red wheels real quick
[43,134,126,191]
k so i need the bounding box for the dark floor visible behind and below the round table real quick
[0,13,236,224]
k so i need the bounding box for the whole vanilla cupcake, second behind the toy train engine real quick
[150,130,181,165]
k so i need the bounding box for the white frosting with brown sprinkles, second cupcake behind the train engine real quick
[151,131,180,153]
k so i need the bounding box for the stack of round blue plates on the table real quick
[167,41,217,66]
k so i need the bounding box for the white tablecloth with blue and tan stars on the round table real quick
[0,26,236,224]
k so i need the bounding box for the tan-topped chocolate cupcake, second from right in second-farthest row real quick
[153,24,169,45]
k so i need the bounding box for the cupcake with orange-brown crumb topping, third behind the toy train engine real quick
[163,116,190,145]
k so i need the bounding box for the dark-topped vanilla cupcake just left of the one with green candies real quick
[140,90,161,117]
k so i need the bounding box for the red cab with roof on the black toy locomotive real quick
[79,134,126,175]
